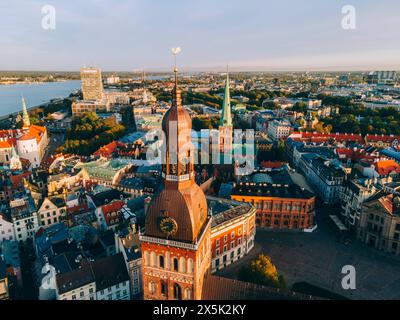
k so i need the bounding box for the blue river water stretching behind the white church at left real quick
[0,80,81,116]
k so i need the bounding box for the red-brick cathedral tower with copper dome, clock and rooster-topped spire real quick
[141,68,211,300]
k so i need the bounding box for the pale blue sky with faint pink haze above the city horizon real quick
[0,0,400,71]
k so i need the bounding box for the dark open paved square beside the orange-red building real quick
[218,205,400,299]
